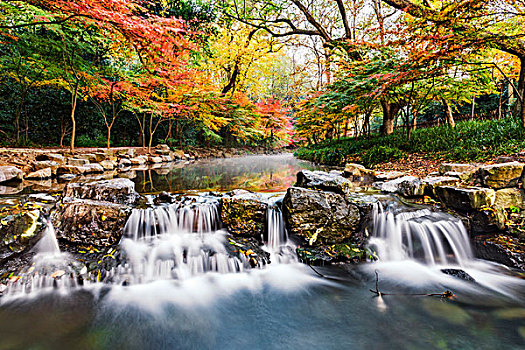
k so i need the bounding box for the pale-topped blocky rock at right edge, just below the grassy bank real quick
[479,162,525,189]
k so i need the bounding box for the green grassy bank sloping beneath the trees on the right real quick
[296,118,525,167]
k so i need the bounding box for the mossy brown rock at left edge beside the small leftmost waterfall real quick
[0,208,42,262]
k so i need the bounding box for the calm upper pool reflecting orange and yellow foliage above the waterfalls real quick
[133,154,322,193]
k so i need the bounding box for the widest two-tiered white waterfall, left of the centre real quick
[113,198,249,284]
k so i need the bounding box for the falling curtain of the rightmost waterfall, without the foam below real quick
[370,204,474,266]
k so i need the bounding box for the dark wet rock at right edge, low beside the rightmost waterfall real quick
[474,235,525,270]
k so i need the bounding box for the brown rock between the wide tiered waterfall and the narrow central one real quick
[220,193,268,238]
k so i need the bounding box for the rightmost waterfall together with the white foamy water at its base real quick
[365,202,524,300]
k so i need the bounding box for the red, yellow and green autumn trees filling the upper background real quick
[0,0,525,150]
